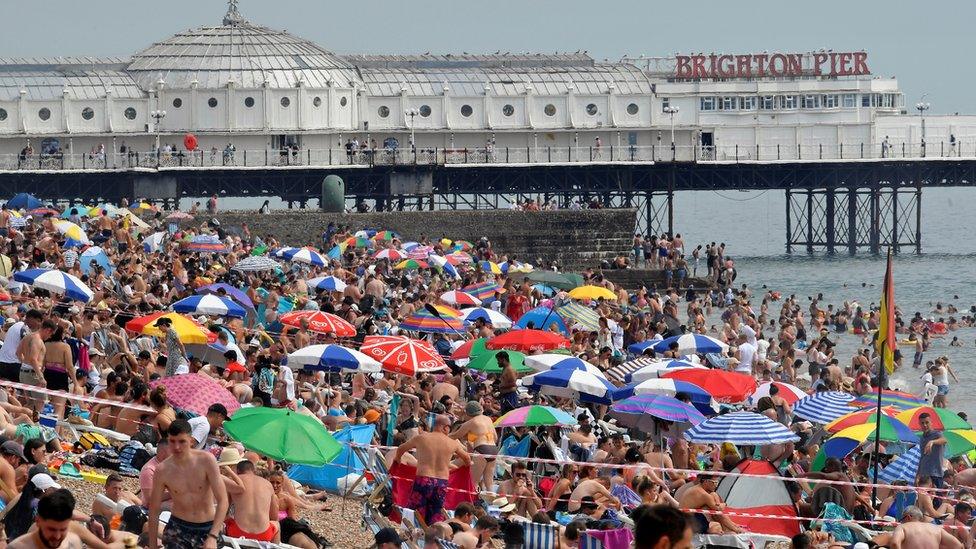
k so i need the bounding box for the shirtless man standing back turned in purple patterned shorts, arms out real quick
[394,414,471,524]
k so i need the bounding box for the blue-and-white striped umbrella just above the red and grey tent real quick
[684,412,800,446]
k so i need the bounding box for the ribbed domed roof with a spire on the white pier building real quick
[127,1,356,89]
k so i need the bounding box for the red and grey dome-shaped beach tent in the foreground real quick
[716,459,800,538]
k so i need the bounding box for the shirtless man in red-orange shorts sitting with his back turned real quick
[220,454,281,543]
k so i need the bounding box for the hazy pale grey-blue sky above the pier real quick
[0,0,976,113]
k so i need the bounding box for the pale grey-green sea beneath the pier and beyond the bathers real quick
[196,188,976,418]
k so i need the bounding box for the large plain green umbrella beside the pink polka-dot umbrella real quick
[224,406,342,466]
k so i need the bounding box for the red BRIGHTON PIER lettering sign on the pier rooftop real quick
[674,51,871,79]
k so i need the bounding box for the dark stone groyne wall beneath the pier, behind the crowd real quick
[211,209,637,269]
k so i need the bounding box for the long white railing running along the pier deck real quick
[0,141,976,172]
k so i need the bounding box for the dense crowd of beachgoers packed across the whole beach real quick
[0,197,960,549]
